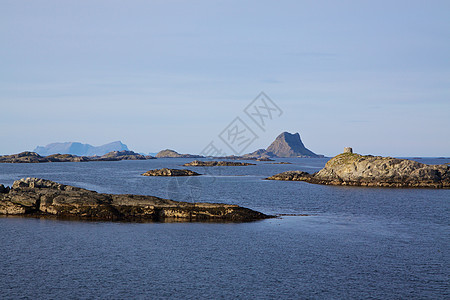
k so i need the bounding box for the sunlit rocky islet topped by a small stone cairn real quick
[267,153,450,188]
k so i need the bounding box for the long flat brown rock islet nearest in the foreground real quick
[0,178,271,222]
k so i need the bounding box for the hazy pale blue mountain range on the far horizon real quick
[34,141,129,156]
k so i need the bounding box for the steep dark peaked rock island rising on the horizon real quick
[242,132,324,158]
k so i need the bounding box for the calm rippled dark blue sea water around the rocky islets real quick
[0,159,450,299]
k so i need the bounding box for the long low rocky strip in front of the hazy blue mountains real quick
[0,150,154,163]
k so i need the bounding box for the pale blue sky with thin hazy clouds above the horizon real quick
[0,0,450,157]
